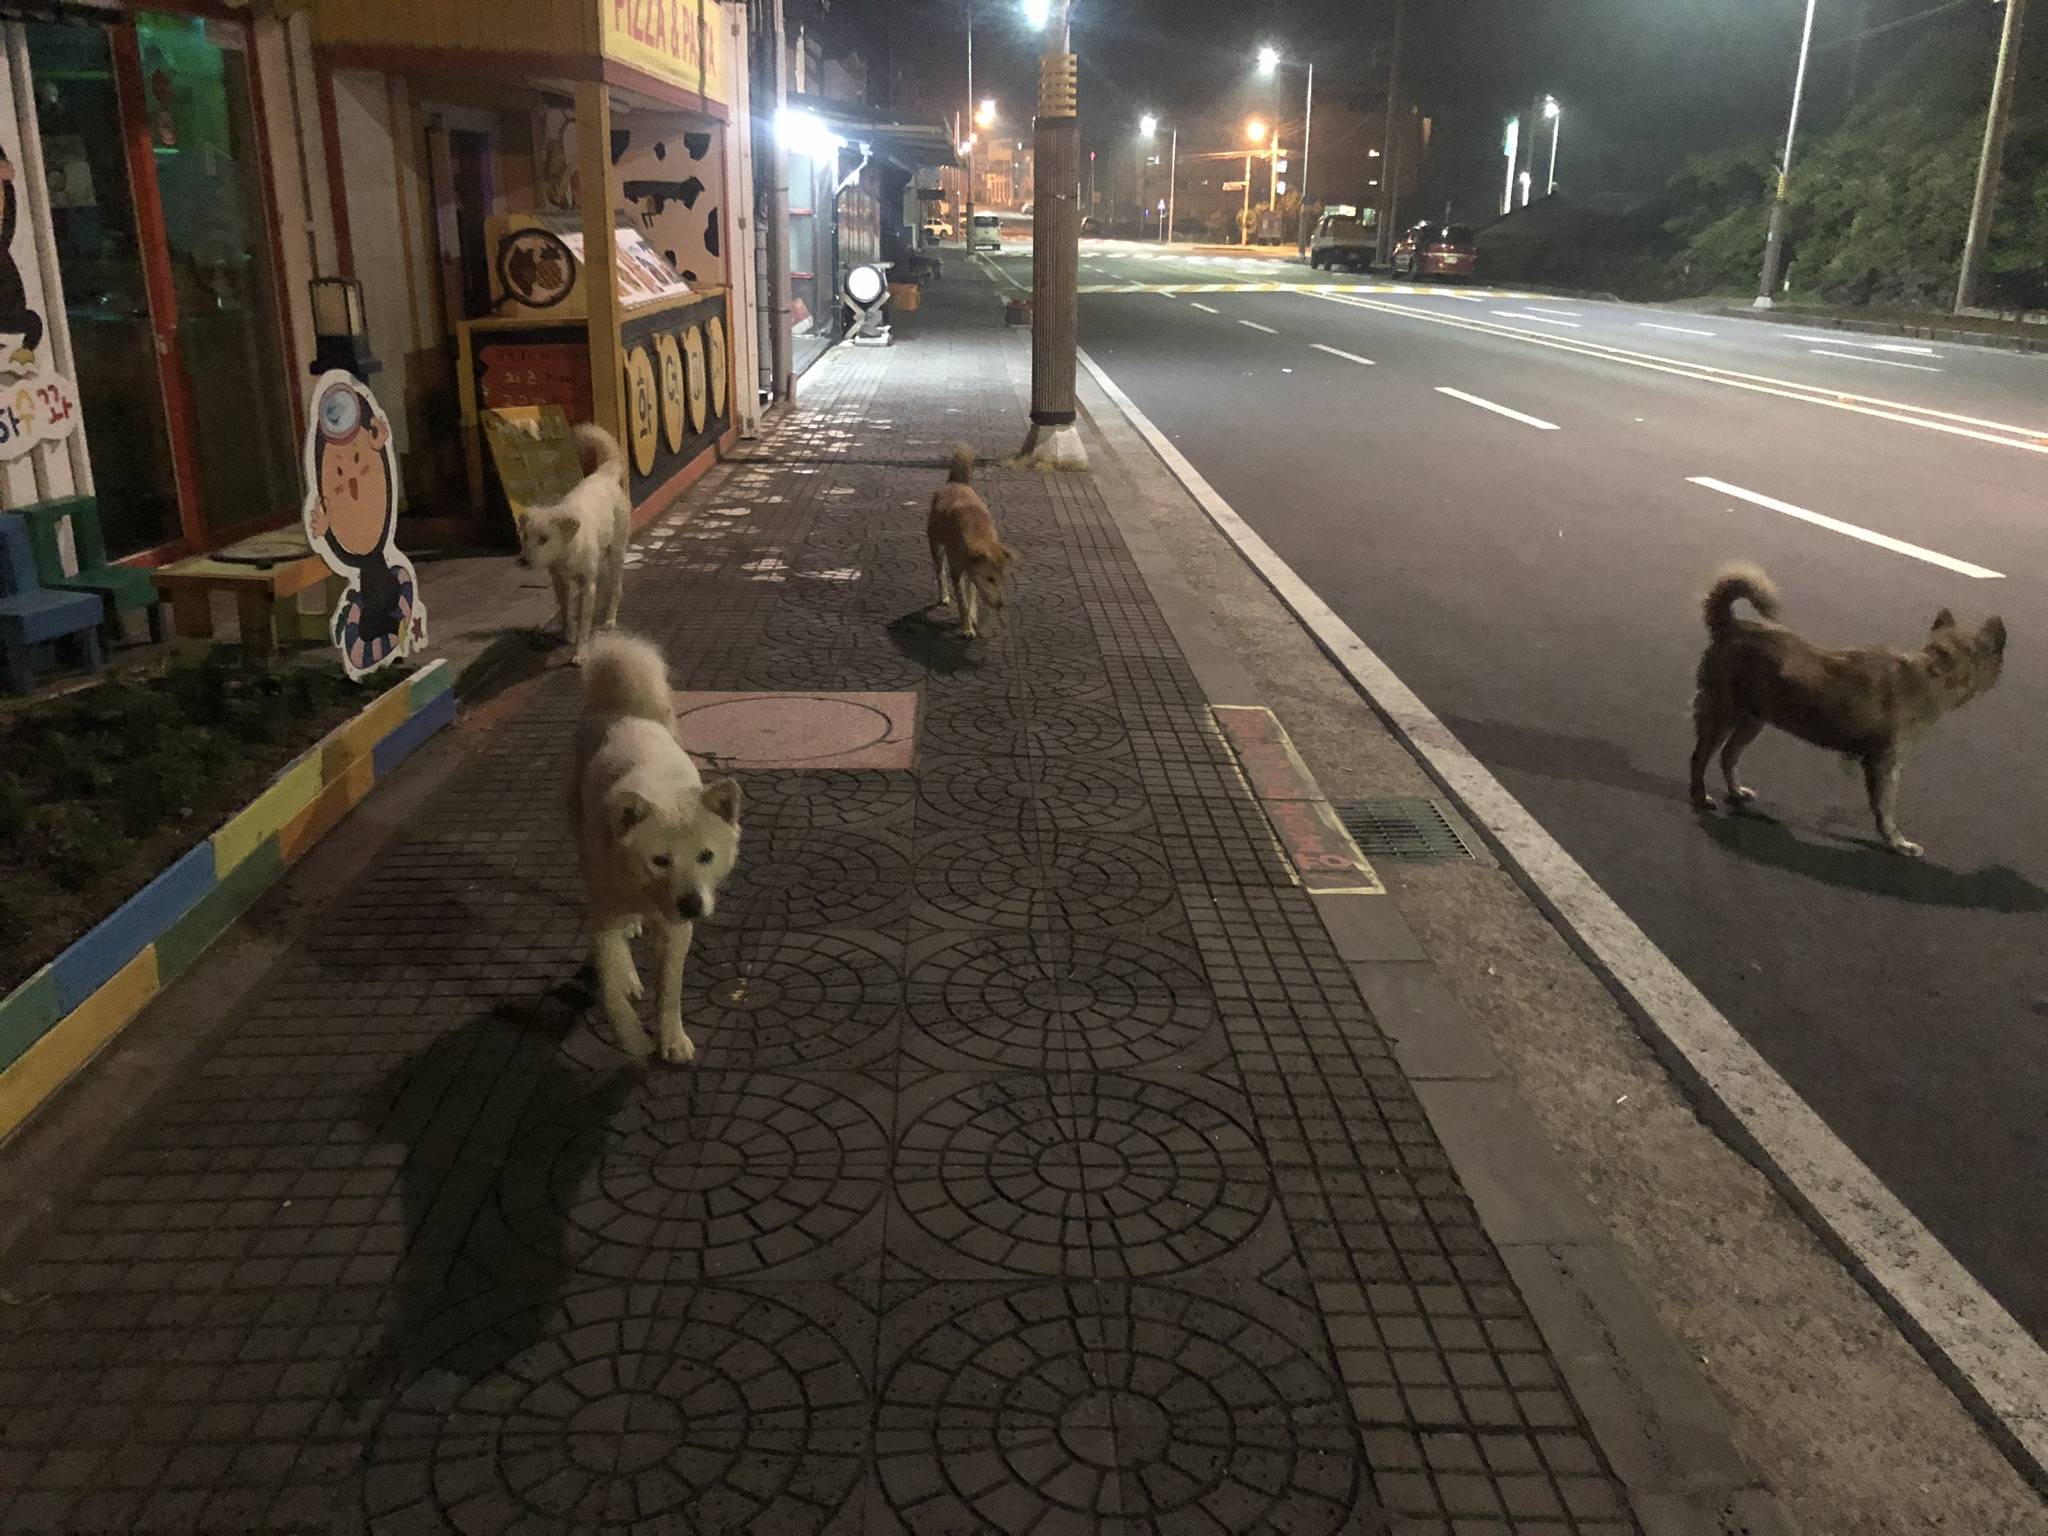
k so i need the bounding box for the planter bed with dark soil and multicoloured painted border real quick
[0,659,455,1137]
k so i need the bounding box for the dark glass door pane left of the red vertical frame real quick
[25,23,180,557]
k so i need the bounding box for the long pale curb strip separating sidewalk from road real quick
[1081,352,2048,1481]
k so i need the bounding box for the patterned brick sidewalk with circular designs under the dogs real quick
[0,283,1634,1536]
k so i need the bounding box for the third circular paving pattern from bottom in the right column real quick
[909,934,1214,1071]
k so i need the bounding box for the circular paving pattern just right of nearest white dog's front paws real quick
[686,930,903,1071]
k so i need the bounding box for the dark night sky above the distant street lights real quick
[872,0,1997,213]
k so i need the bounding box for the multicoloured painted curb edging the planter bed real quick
[0,659,455,1141]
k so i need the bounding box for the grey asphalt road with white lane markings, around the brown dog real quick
[987,244,2048,1339]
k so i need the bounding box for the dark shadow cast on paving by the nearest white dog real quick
[344,987,641,1413]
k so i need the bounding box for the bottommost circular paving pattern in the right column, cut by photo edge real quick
[879,1286,1370,1536]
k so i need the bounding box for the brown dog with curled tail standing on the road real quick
[1692,565,2005,858]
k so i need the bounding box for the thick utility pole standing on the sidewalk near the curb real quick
[1022,0,1087,469]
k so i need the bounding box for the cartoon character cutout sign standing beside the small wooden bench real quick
[303,369,426,678]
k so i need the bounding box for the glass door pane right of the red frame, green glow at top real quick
[136,16,299,543]
